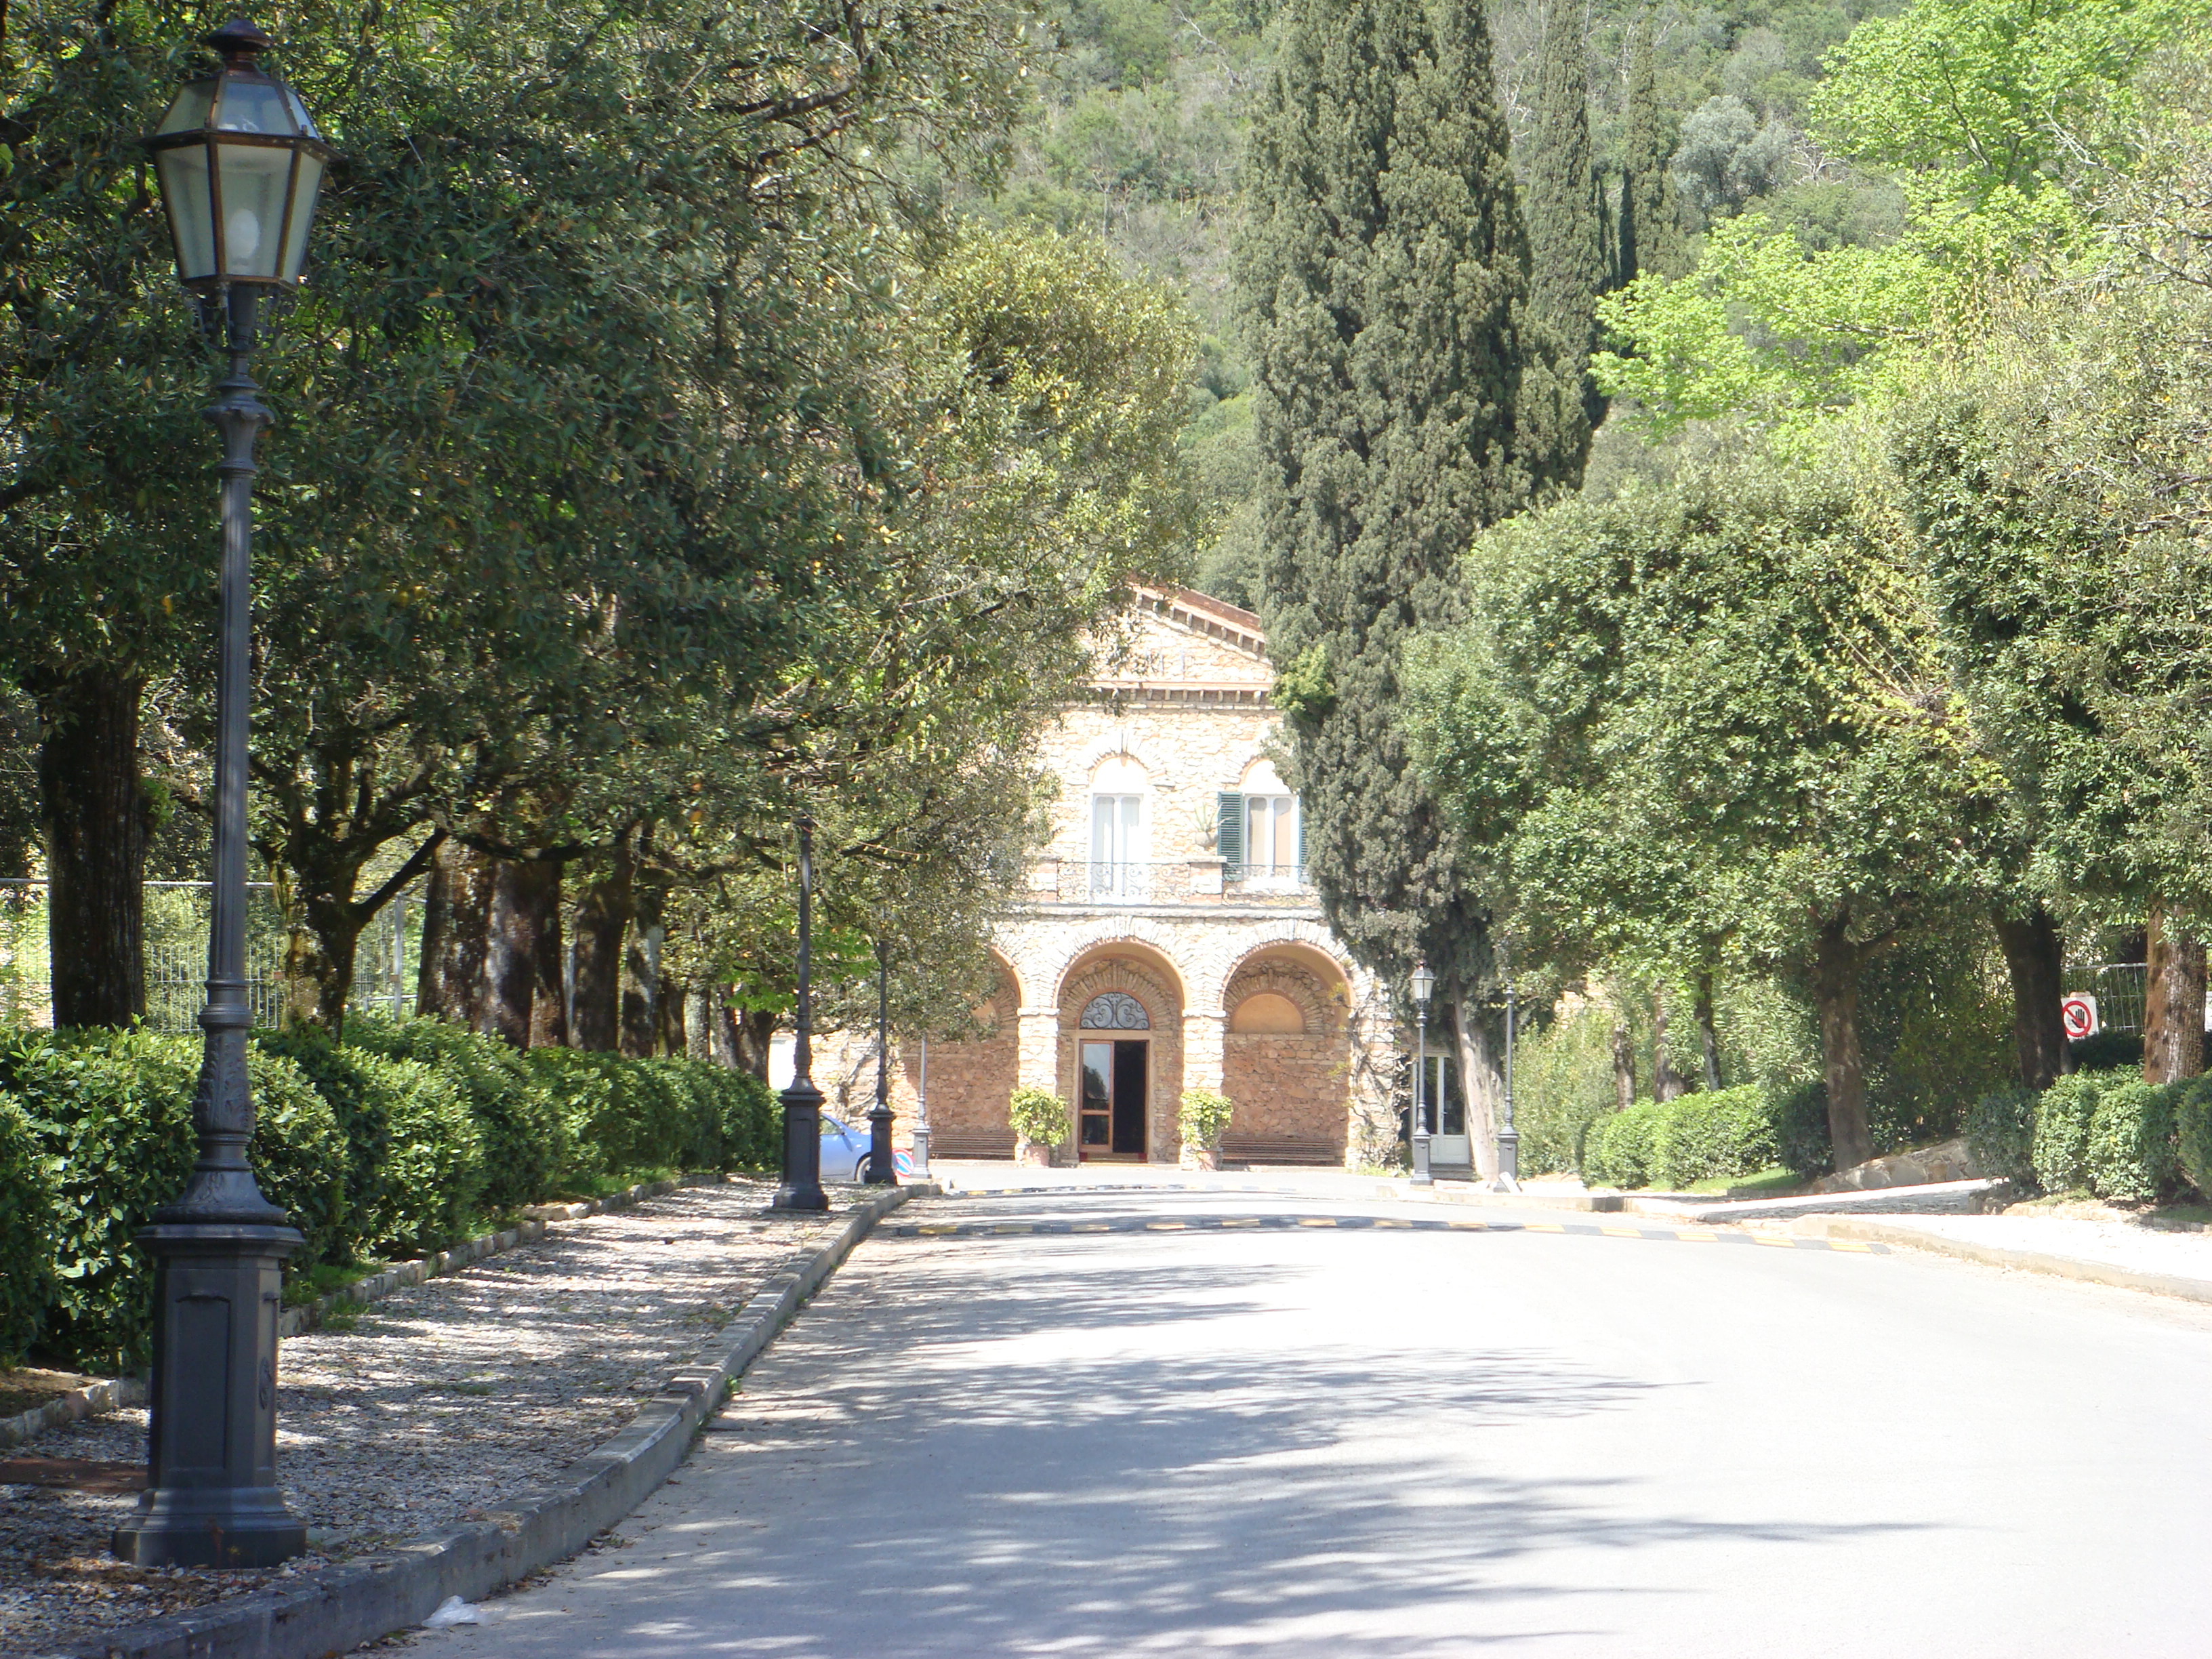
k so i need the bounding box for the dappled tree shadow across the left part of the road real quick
[471,1239,1938,1659]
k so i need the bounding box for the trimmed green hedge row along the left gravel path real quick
[0,1020,779,1372]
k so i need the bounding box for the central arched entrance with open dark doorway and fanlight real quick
[1059,942,1183,1164]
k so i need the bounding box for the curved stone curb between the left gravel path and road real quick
[68,1183,936,1659]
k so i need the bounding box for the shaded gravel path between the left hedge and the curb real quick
[0,1181,849,1654]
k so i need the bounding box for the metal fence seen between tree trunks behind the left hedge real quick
[0,880,422,1031]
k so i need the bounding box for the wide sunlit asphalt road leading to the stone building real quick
[411,1192,2212,1659]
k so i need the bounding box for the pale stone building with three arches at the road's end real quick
[814,590,1400,1164]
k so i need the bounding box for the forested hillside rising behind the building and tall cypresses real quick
[969,0,1902,604]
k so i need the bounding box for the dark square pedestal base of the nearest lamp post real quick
[108,1221,308,1566]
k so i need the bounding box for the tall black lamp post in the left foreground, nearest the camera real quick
[112,20,332,1566]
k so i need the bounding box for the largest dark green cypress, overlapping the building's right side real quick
[1239,0,1575,1157]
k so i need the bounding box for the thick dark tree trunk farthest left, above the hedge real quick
[37,668,148,1026]
